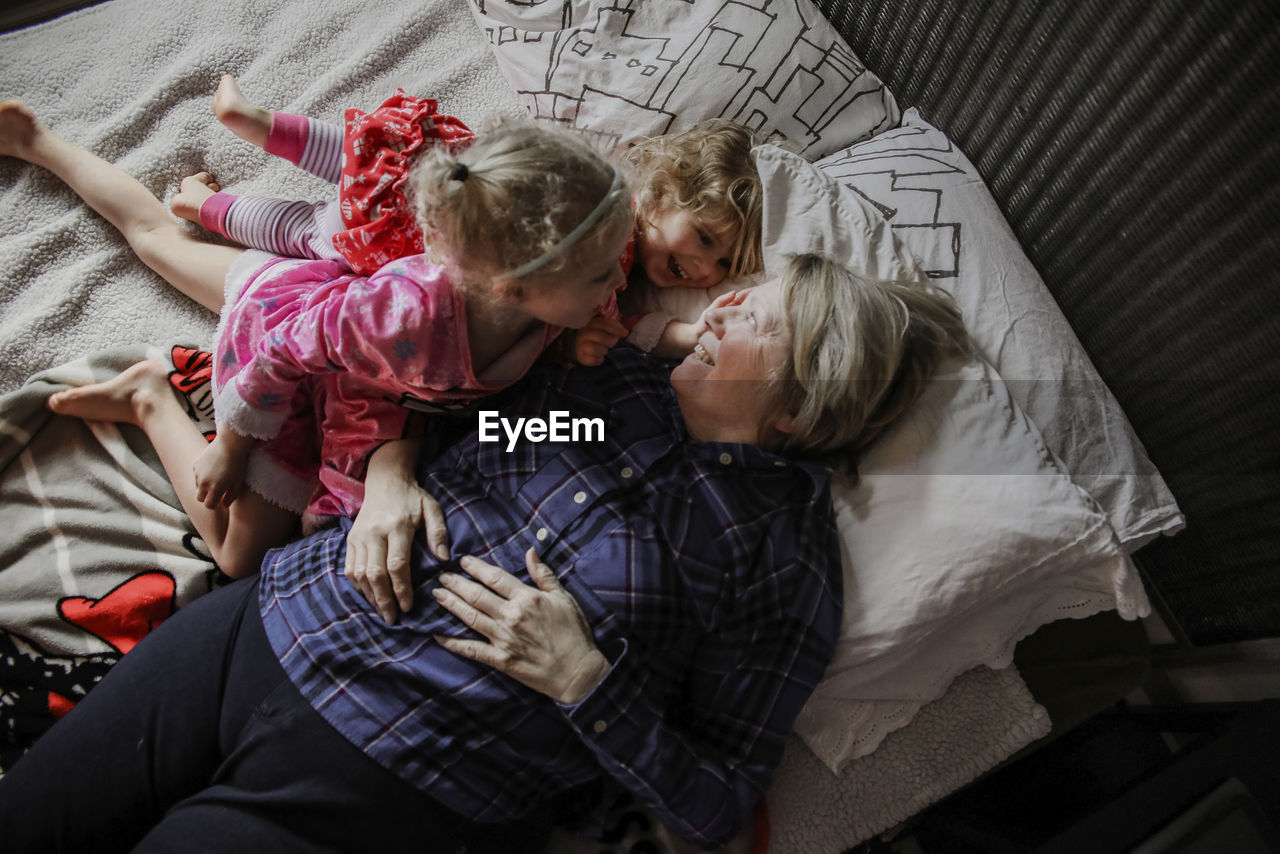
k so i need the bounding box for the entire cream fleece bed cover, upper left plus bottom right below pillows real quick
[0,0,1048,854]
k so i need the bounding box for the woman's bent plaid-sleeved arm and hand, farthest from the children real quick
[436,537,840,846]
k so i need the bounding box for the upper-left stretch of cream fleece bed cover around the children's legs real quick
[0,0,520,392]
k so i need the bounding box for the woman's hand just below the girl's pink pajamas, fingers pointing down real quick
[346,439,449,625]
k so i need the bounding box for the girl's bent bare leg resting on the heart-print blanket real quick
[49,360,298,577]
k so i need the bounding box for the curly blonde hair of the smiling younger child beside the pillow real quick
[625,119,764,275]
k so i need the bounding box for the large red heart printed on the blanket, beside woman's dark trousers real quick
[58,571,177,654]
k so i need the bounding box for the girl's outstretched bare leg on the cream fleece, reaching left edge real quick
[0,101,241,311]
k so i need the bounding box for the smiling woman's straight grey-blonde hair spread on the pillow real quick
[774,255,969,460]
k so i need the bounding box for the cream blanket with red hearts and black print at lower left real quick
[0,346,223,773]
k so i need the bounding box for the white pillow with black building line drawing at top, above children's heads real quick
[471,0,900,159]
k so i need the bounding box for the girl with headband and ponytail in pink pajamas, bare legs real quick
[0,90,632,576]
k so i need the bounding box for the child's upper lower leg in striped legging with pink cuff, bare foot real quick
[214,74,342,184]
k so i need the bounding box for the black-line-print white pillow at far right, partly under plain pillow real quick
[817,109,1184,553]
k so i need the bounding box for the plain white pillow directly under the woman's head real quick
[755,146,1149,771]
